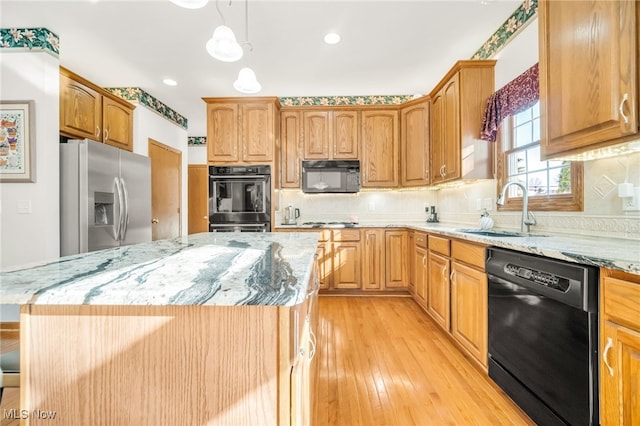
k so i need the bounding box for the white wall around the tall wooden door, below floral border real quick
[133,105,189,235]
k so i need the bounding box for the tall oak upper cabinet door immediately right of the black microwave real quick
[360,110,398,188]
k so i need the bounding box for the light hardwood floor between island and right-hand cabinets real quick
[314,296,534,426]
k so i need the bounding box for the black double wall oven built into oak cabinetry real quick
[209,165,271,232]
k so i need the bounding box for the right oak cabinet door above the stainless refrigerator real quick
[102,97,133,151]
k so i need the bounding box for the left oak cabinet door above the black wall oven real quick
[207,103,240,163]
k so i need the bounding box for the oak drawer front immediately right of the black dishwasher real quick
[602,276,640,327]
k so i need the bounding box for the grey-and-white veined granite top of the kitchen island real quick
[0,232,318,306]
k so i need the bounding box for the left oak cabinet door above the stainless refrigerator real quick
[60,73,102,141]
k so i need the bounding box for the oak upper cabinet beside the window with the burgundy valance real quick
[430,60,496,184]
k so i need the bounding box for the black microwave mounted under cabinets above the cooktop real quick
[302,160,360,193]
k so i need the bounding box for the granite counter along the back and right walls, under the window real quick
[275,221,640,274]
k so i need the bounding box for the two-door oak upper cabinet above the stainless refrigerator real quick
[60,67,135,151]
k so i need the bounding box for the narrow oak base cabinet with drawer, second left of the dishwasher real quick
[427,235,451,332]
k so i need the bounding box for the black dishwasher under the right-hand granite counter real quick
[486,247,599,425]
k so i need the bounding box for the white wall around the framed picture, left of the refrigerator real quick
[0,49,60,270]
